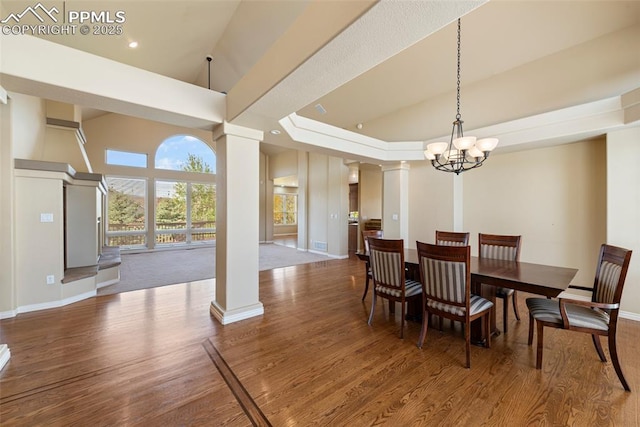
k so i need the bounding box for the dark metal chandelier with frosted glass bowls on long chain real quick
[424,18,498,175]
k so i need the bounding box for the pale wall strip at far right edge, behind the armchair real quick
[607,127,640,320]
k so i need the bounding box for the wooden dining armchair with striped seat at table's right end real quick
[527,244,632,391]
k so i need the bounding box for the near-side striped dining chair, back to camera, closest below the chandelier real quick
[416,241,493,368]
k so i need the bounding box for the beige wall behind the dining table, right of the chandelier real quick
[463,139,607,286]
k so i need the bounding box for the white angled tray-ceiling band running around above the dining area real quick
[279,95,640,162]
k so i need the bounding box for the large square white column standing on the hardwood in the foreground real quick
[210,122,264,325]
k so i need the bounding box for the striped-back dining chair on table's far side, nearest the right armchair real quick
[478,233,521,333]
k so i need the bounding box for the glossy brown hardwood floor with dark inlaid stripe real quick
[0,259,640,426]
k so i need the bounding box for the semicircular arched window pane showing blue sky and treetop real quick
[155,135,216,174]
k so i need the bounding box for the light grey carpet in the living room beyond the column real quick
[98,243,330,295]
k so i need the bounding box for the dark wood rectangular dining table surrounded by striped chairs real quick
[356,249,578,343]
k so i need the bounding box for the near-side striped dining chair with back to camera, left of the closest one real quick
[368,237,422,338]
